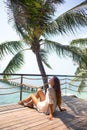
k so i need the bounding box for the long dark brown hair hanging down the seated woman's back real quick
[53,76,62,107]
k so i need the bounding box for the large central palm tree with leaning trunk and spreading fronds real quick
[0,0,87,90]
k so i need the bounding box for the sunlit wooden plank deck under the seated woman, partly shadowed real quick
[0,96,87,130]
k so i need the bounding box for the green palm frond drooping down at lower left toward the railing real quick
[3,52,24,77]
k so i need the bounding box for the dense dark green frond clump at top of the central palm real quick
[7,0,64,38]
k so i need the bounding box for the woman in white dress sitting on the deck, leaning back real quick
[18,77,66,120]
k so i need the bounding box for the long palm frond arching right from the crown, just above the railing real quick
[44,40,85,62]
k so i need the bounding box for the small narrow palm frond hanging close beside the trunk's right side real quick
[40,49,52,69]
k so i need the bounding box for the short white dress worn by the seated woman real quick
[37,88,57,114]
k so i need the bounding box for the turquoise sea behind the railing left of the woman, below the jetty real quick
[0,82,34,105]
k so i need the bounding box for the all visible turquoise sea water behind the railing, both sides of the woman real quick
[0,76,87,105]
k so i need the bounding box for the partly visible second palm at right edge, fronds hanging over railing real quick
[70,38,87,92]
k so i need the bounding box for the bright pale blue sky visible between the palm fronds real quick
[0,0,87,75]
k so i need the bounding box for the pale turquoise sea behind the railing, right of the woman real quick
[60,77,87,100]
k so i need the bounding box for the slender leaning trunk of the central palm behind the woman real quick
[35,52,48,93]
